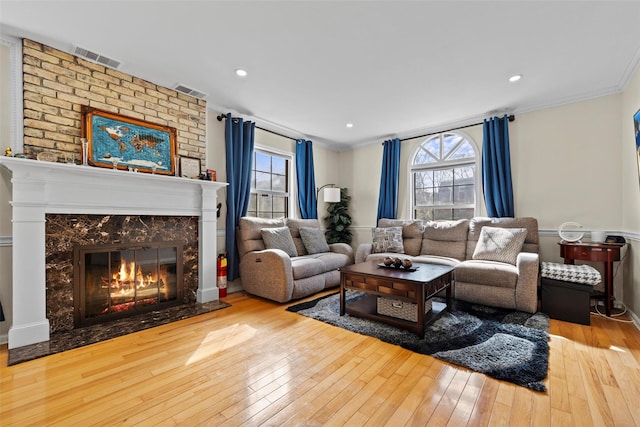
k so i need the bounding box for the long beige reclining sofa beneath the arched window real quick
[355,217,539,313]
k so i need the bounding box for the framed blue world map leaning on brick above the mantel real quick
[80,106,177,175]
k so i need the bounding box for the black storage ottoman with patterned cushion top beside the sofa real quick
[540,262,602,325]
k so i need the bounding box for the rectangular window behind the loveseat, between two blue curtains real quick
[247,149,291,218]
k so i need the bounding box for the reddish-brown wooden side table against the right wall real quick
[558,242,625,316]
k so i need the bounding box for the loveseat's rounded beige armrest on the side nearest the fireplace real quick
[240,249,293,302]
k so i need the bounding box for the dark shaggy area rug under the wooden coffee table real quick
[287,291,549,391]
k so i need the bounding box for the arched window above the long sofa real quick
[411,132,478,220]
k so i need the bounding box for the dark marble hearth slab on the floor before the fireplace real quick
[7,300,231,366]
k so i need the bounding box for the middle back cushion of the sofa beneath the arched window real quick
[420,219,469,261]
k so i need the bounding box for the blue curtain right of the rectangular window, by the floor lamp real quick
[296,139,318,219]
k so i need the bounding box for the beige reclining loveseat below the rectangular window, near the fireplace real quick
[236,217,353,302]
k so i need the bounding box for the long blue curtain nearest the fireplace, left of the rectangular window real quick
[224,113,256,281]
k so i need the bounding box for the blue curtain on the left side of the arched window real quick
[376,138,400,224]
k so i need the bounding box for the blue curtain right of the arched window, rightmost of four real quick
[482,115,515,218]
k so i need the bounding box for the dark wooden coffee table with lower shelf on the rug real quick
[340,262,455,338]
